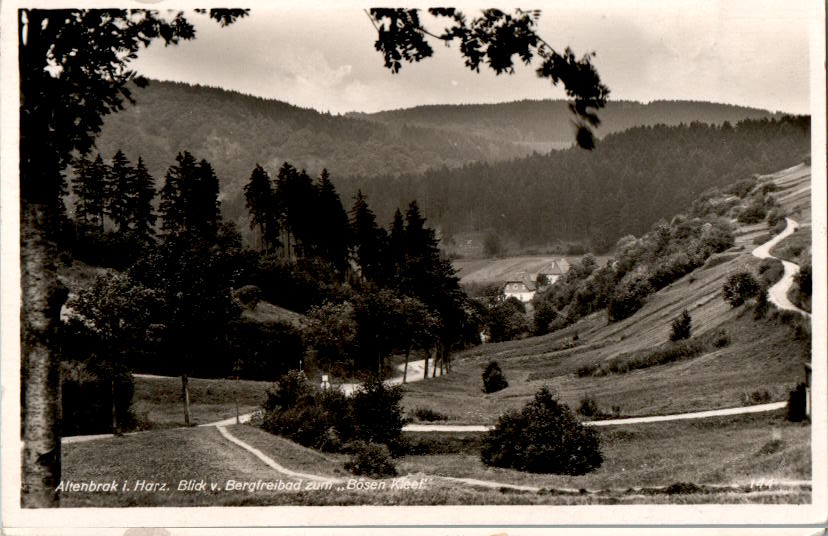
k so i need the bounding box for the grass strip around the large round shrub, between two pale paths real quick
[399,411,811,490]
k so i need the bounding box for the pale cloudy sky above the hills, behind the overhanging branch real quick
[135,0,814,113]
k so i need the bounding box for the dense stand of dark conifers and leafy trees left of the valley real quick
[61,151,479,432]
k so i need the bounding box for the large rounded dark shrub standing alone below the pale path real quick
[480,387,603,475]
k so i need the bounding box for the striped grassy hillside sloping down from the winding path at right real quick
[404,166,810,423]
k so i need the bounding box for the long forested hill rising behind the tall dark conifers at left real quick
[90,81,526,199]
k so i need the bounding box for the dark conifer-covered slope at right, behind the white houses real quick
[334,117,810,251]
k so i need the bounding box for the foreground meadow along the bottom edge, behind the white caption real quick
[62,412,810,506]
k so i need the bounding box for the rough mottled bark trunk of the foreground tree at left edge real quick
[20,203,68,508]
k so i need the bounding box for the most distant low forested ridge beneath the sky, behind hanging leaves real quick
[349,100,779,153]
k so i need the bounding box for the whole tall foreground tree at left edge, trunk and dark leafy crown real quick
[17,9,247,507]
